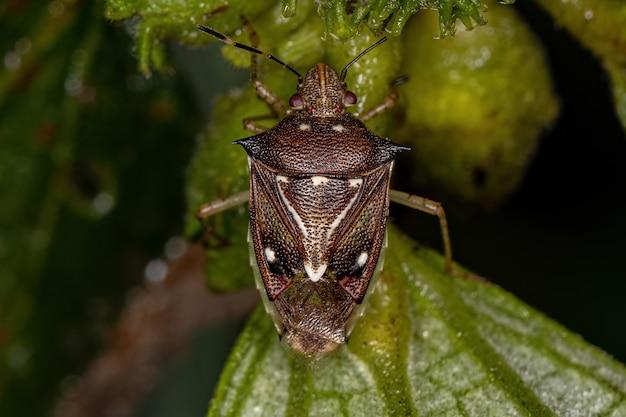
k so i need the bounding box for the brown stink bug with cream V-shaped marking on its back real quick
[197,22,451,355]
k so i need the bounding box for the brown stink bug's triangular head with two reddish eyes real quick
[289,63,356,117]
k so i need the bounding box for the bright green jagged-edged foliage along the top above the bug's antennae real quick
[106,0,486,74]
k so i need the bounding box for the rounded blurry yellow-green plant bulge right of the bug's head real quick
[394,2,558,208]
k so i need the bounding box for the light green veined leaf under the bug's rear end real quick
[208,228,626,417]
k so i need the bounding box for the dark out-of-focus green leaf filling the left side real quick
[0,0,194,416]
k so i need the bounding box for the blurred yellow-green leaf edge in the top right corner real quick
[537,0,626,129]
